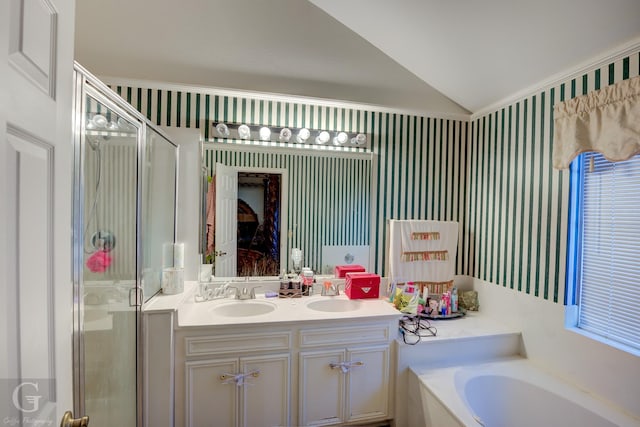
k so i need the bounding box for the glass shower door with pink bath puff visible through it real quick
[76,85,143,426]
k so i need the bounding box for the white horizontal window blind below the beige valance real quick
[576,153,640,349]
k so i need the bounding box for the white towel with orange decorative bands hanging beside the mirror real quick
[389,220,458,282]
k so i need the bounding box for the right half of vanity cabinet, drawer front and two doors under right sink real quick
[298,323,393,426]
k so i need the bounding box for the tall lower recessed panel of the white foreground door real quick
[4,126,56,421]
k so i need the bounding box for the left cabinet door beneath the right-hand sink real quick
[299,350,346,426]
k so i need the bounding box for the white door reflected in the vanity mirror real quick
[215,163,238,277]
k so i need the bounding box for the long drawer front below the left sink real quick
[184,332,291,357]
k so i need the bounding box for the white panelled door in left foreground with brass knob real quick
[0,0,75,426]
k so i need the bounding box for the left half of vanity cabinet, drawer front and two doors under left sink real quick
[176,332,291,427]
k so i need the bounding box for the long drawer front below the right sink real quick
[299,323,391,348]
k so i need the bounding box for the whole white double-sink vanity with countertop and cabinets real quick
[143,283,400,427]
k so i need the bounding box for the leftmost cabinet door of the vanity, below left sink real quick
[184,358,239,427]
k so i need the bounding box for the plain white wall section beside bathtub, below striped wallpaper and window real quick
[473,279,640,418]
